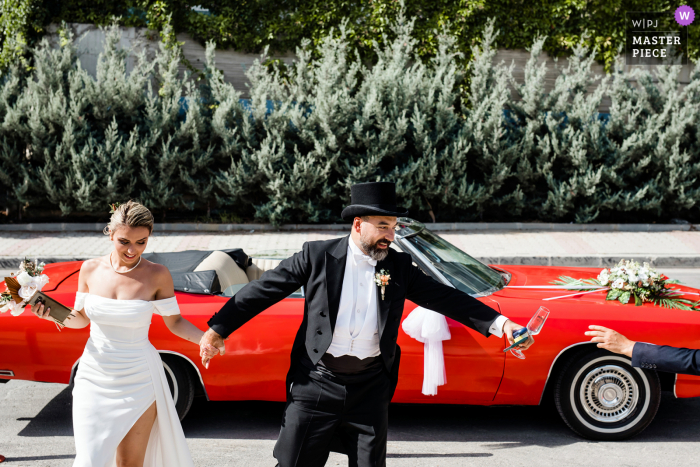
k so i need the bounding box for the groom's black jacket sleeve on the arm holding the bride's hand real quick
[207,243,311,338]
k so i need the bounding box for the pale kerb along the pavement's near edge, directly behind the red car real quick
[5,255,700,269]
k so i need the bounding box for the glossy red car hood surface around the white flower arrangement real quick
[492,265,700,306]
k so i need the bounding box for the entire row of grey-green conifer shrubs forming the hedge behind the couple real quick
[0,16,700,224]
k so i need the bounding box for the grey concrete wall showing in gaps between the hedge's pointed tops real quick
[50,23,692,108]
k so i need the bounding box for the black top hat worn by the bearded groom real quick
[340,182,408,221]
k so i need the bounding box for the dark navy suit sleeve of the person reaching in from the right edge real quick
[632,342,700,375]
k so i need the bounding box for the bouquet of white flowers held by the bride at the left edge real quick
[0,259,49,316]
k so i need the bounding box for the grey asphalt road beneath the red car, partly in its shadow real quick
[0,381,700,467]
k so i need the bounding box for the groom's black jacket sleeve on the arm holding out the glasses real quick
[406,265,500,337]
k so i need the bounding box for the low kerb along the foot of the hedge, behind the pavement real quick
[0,222,700,232]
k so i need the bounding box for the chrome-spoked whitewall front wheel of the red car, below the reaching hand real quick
[554,349,661,441]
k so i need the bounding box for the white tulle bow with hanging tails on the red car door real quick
[402,306,452,396]
